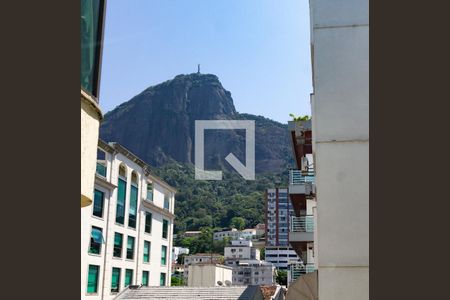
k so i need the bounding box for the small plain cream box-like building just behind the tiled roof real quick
[188,264,233,287]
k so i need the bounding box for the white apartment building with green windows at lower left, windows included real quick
[81,140,176,299]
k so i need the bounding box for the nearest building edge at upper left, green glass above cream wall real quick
[80,0,106,207]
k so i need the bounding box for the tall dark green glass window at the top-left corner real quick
[80,0,105,97]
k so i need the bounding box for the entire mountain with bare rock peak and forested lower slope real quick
[100,74,293,232]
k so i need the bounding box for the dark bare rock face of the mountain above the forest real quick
[100,73,291,172]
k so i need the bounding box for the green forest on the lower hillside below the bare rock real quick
[154,162,288,233]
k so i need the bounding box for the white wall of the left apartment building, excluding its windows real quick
[81,144,175,299]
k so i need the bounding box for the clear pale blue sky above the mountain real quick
[100,0,312,123]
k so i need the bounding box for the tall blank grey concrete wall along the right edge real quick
[310,0,369,300]
